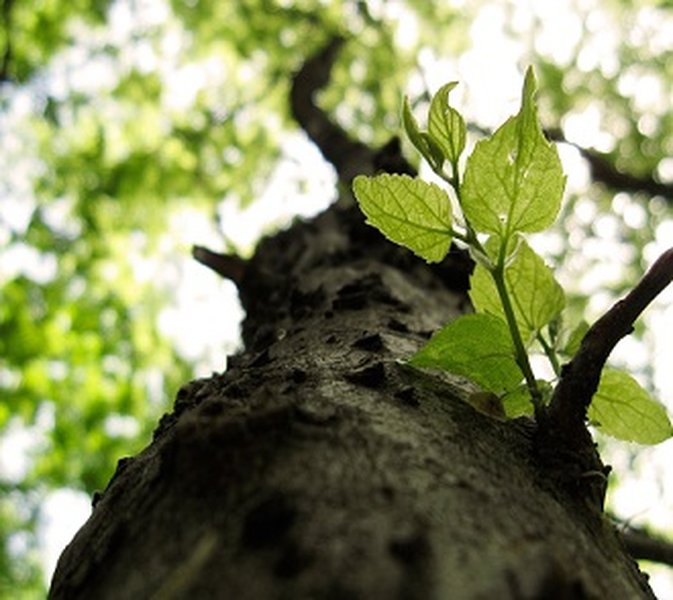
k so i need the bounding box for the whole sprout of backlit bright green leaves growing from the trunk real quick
[353,69,673,444]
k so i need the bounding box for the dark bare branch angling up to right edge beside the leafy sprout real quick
[548,248,673,435]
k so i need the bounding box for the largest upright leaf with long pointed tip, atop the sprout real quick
[462,69,565,239]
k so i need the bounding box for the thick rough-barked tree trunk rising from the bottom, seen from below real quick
[50,199,653,600]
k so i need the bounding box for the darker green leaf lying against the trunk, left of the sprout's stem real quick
[409,314,522,394]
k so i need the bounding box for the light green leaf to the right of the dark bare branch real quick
[589,369,673,444]
